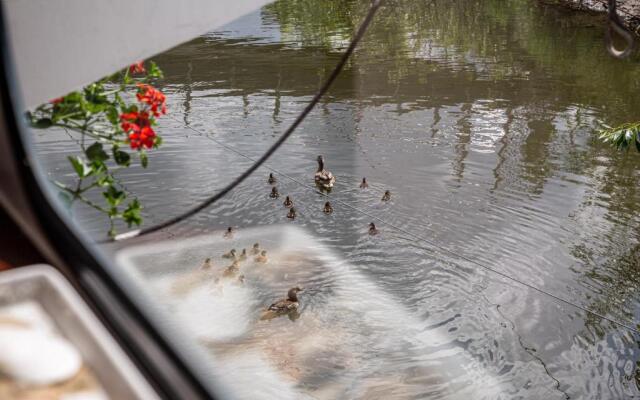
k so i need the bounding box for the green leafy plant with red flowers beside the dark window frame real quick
[27,61,167,237]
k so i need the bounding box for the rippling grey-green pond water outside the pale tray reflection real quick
[31,0,640,399]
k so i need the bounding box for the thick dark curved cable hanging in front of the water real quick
[107,0,382,243]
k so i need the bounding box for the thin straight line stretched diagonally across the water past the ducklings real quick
[165,118,640,334]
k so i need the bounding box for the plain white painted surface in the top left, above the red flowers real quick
[2,0,268,108]
